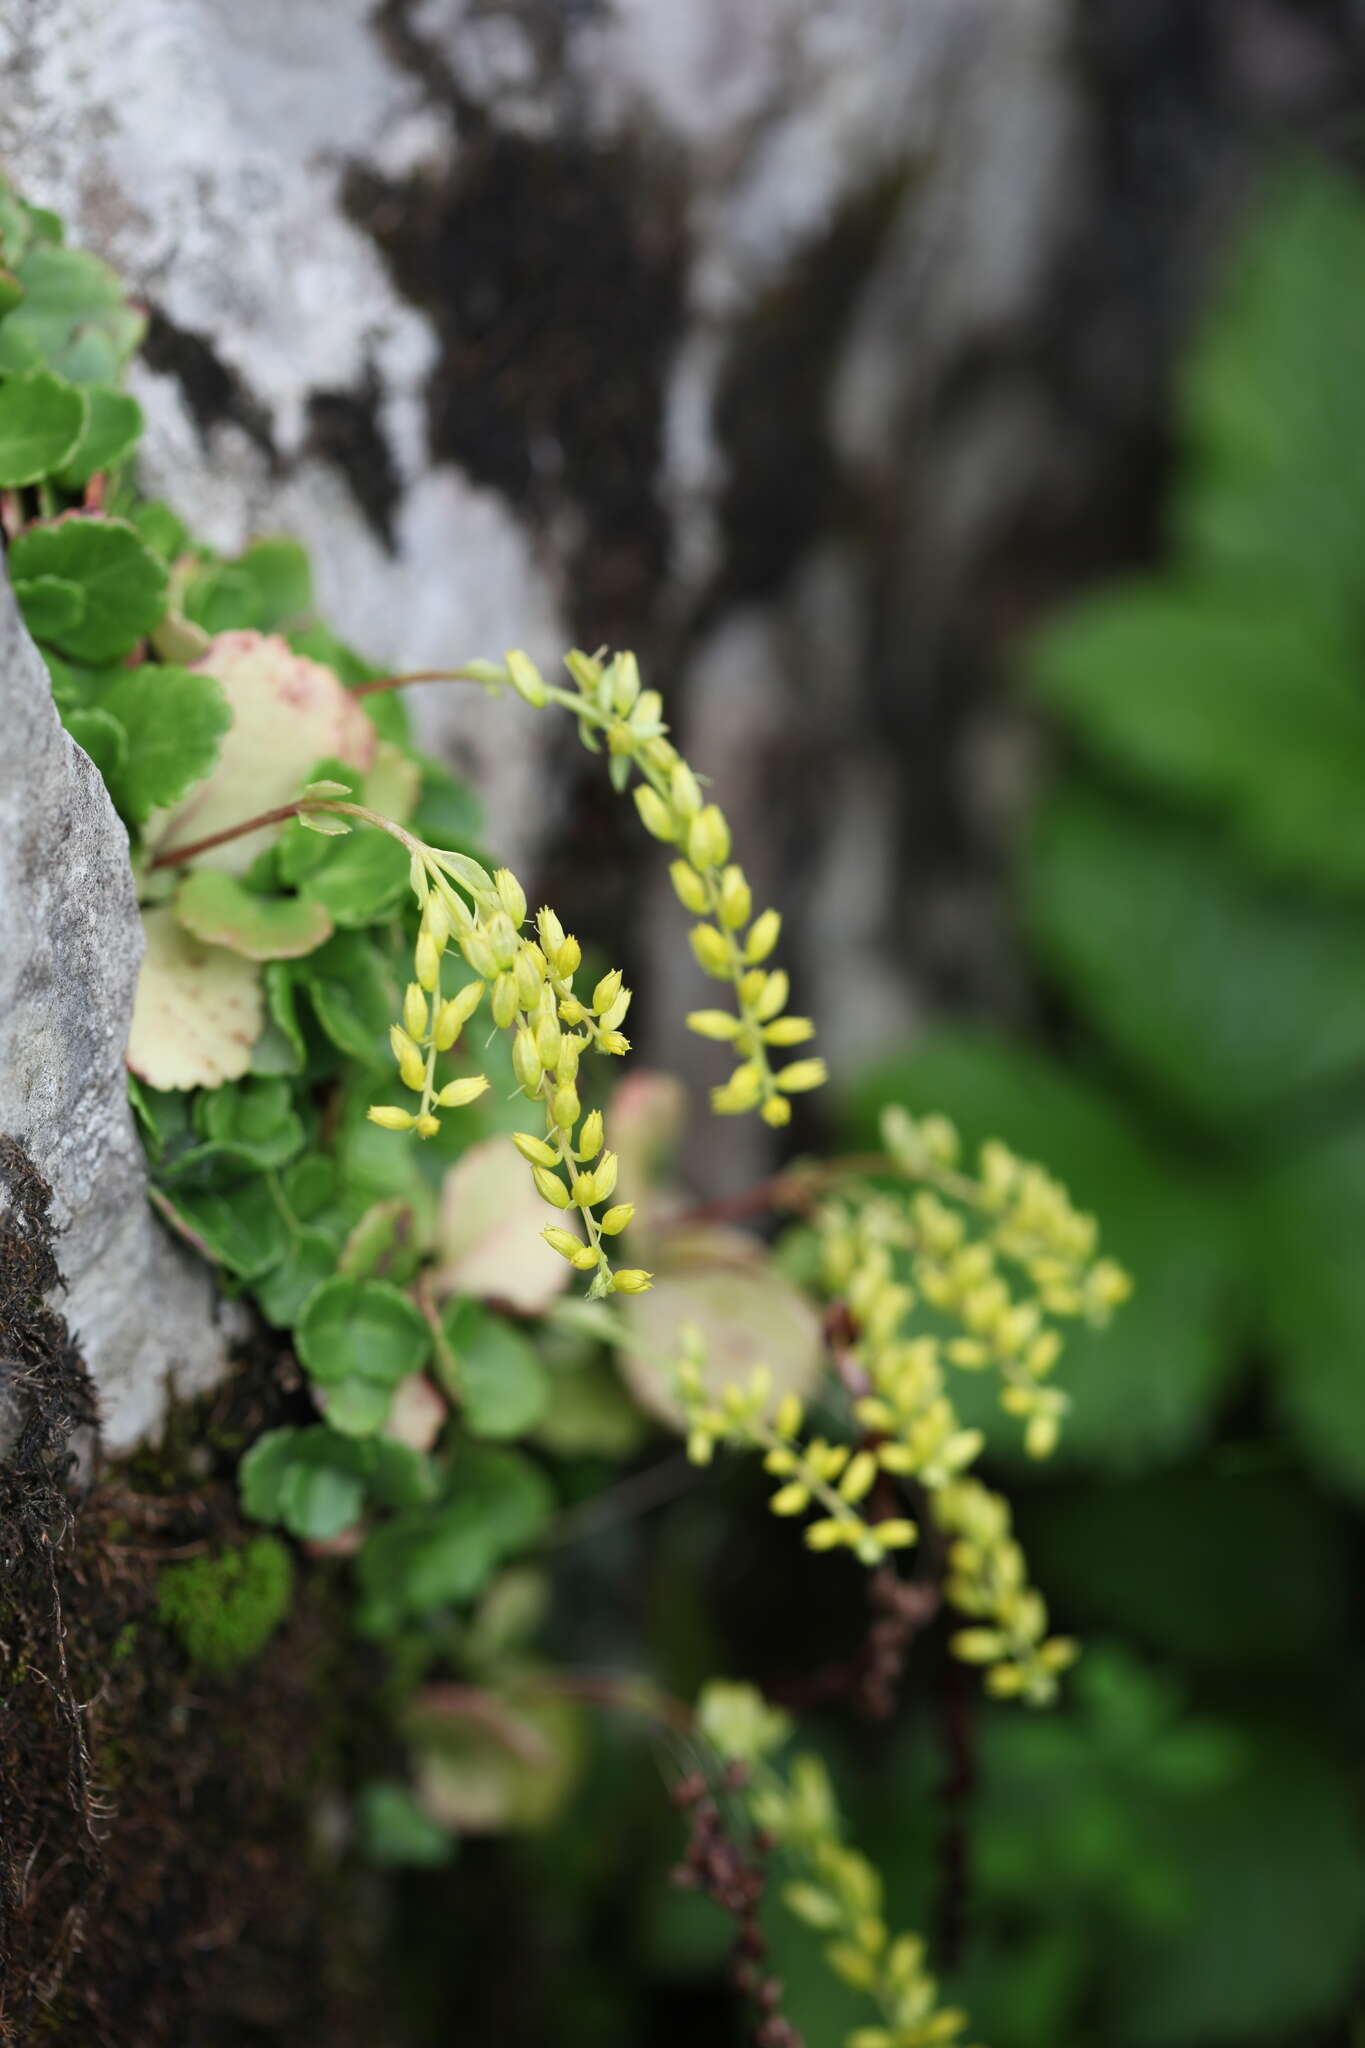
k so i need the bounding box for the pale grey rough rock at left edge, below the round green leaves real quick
[0,571,225,1450]
